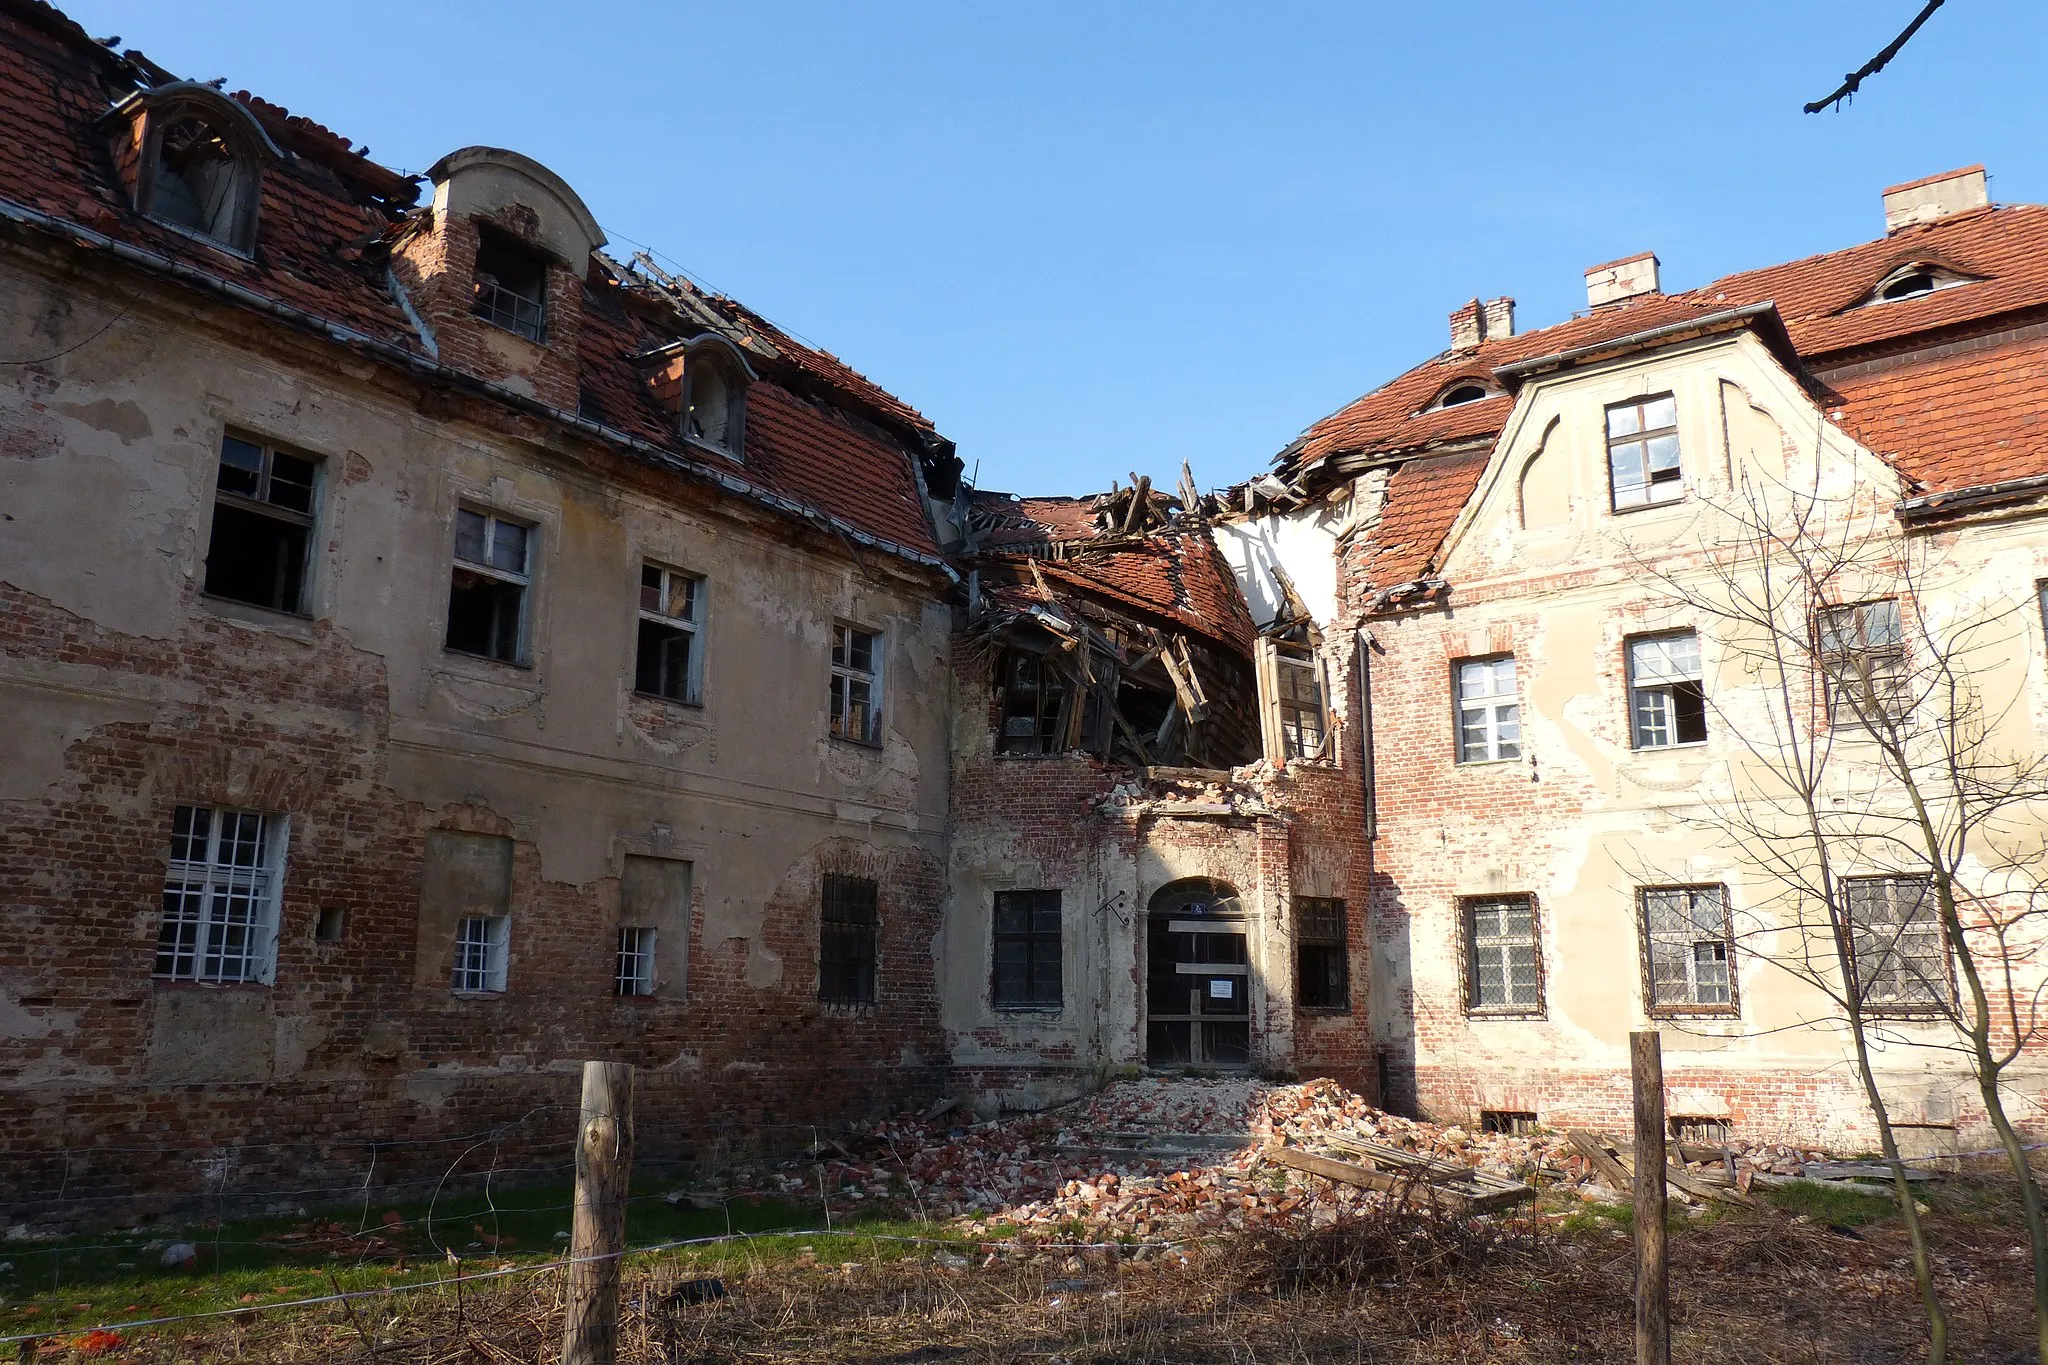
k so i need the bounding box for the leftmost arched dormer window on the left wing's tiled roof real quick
[117,82,285,256]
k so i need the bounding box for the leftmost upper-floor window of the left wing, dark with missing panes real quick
[205,434,315,612]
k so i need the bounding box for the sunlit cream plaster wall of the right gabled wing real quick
[1354,338,2048,1148]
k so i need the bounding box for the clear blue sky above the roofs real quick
[66,0,2048,493]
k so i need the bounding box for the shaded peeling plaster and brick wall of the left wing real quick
[0,256,950,1220]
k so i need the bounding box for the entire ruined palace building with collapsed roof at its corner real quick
[0,0,2048,1222]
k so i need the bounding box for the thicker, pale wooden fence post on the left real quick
[561,1062,633,1365]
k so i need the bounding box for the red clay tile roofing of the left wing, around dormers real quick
[0,0,944,557]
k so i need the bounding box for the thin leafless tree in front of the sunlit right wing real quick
[1638,475,2048,1365]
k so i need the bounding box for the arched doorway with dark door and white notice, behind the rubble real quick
[1145,876,1251,1066]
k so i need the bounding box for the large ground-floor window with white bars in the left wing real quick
[154,806,287,984]
